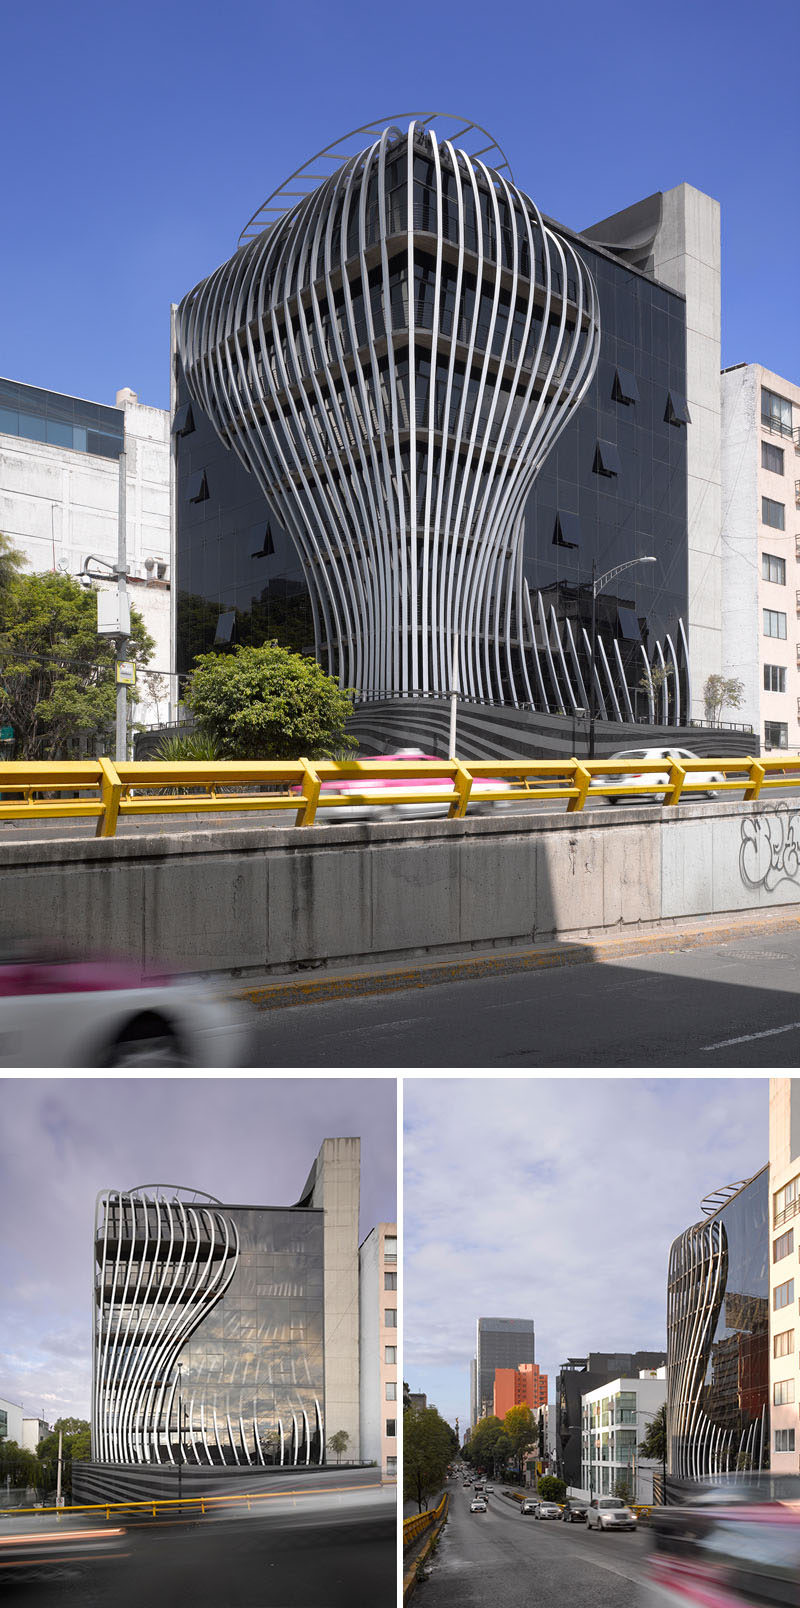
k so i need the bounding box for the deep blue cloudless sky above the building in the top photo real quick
[0,0,800,407]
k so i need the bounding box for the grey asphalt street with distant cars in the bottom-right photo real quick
[414,1487,649,1608]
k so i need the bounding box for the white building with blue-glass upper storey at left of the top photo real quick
[0,379,172,724]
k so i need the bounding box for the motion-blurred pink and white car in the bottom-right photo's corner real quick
[644,1500,800,1608]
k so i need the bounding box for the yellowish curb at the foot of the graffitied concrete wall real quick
[231,910,800,1010]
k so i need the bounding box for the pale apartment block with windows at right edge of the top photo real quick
[721,363,800,753]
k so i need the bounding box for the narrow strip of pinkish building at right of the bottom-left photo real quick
[358,1222,396,1478]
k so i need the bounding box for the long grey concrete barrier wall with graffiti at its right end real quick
[0,799,800,978]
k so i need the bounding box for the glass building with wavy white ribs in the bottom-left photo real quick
[85,1138,360,1498]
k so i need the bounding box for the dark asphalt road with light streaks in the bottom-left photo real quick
[0,1487,397,1608]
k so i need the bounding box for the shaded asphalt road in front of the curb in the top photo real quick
[249,928,800,1071]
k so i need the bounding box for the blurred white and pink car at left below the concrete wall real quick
[0,944,249,1068]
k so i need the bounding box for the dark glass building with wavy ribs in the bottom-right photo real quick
[667,1166,771,1481]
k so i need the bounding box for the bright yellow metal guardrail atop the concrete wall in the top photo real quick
[0,754,800,838]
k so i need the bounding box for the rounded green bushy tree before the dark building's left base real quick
[185,642,355,759]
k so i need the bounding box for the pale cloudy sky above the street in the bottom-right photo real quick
[403,1077,769,1428]
